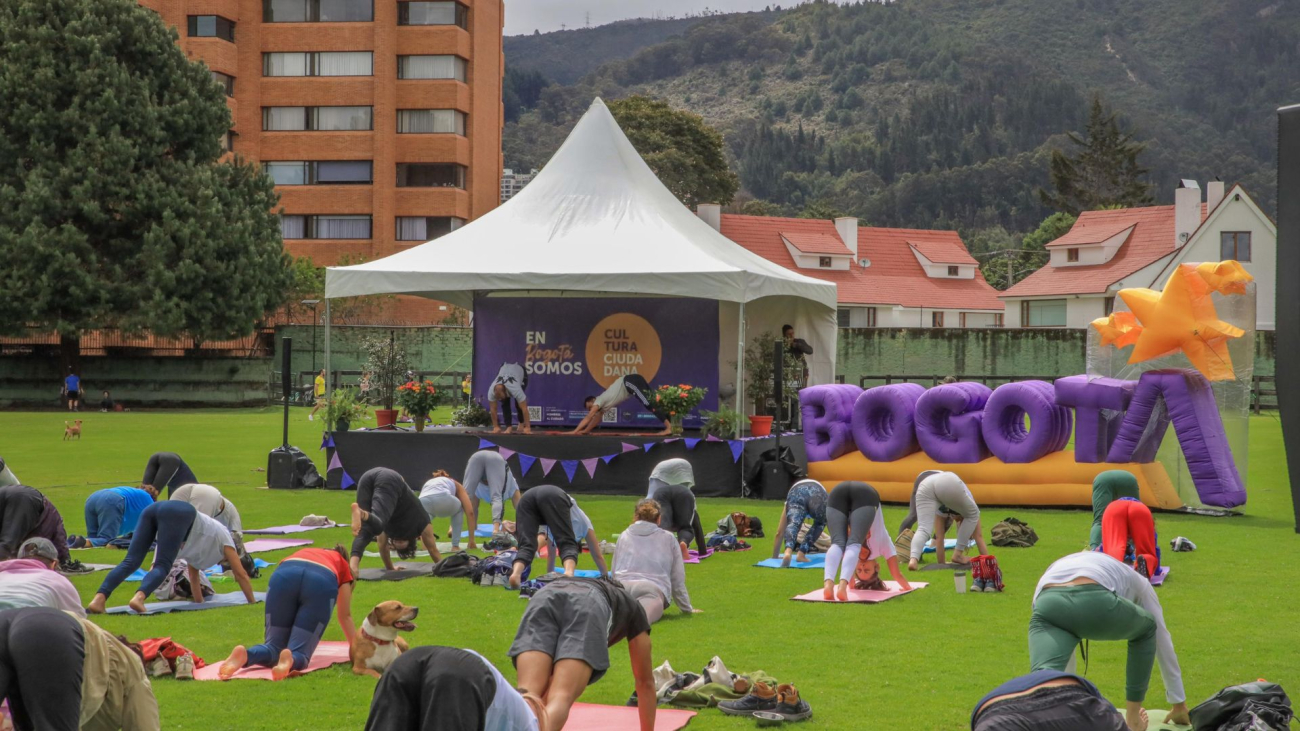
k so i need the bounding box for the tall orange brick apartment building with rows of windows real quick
[140,0,504,265]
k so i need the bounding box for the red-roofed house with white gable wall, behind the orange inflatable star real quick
[1001,181,1278,330]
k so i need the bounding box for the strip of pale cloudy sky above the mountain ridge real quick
[506,0,801,35]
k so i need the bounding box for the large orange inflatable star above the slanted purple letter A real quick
[1119,264,1245,381]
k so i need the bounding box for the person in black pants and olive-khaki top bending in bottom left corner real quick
[0,606,161,731]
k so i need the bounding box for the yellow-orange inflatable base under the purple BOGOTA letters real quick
[809,450,1183,510]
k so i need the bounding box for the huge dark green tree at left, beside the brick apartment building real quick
[0,0,289,362]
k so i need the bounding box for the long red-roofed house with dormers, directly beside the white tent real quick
[698,204,1004,328]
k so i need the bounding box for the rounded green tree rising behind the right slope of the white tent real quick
[610,96,740,209]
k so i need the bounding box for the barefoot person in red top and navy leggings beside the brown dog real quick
[217,545,356,680]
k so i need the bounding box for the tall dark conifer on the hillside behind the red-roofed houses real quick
[1039,95,1154,216]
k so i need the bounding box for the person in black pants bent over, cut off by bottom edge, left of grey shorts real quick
[365,645,551,731]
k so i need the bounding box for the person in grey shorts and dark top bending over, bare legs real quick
[508,574,657,731]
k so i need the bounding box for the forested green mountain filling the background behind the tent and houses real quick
[504,0,1300,244]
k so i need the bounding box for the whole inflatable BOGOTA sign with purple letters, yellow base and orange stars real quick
[800,261,1256,511]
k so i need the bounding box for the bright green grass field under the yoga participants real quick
[0,410,1300,731]
